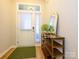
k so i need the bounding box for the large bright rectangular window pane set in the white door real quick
[20,12,32,30]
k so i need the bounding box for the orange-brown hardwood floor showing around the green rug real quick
[0,46,45,59]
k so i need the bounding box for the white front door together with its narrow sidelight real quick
[16,4,41,46]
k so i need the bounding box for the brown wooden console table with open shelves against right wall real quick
[41,32,65,59]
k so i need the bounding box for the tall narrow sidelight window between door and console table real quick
[35,13,41,42]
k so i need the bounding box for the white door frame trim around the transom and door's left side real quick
[16,2,41,46]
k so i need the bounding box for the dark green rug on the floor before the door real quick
[8,47,36,59]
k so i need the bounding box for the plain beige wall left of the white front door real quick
[0,0,15,55]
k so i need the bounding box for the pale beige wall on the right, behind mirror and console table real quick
[46,0,78,59]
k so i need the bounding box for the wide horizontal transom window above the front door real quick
[18,3,41,12]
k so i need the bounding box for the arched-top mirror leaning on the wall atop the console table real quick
[49,12,58,34]
